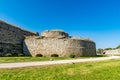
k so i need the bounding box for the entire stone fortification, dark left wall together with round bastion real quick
[0,21,96,57]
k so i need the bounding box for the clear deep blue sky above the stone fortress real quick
[0,0,120,48]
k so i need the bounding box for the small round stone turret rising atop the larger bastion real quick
[41,30,69,38]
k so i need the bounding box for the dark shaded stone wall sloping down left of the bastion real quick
[0,21,36,55]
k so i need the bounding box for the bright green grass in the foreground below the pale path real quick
[0,59,120,80]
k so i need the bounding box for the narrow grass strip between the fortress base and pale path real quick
[0,55,106,63]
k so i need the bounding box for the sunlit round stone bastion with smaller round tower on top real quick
[23,30,96,57]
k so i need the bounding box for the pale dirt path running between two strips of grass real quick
[0,56,120,68]
